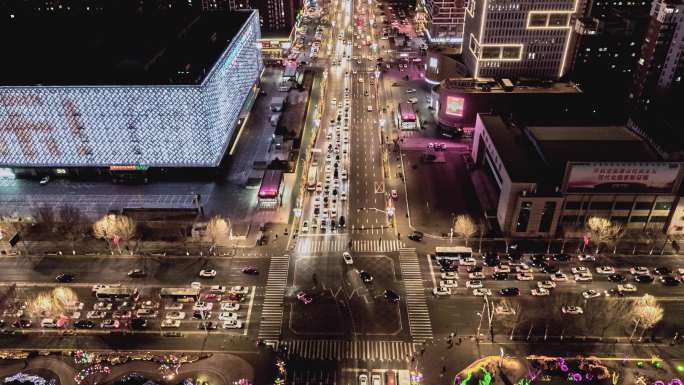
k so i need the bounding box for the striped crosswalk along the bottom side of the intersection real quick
[281,340,415,361]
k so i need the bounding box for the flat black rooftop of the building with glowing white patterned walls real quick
[0,10,250,86]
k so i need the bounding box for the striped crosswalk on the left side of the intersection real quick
[259,254,290,343]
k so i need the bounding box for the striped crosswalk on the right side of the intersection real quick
[399,248,432,342]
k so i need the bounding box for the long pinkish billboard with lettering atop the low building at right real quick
[565,162,681,193]
